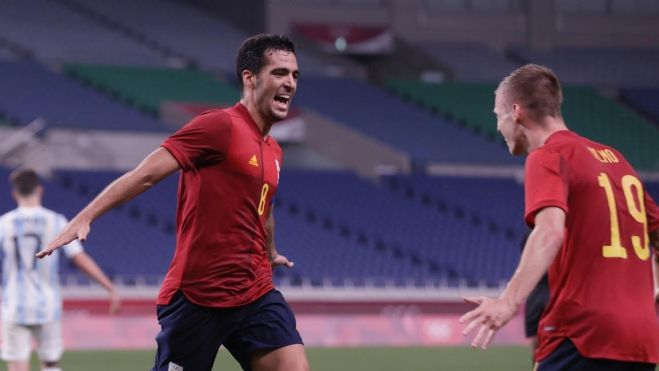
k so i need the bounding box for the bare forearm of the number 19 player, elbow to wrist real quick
[501,218,563,307]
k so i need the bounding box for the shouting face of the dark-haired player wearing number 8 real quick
[254,50,300,122]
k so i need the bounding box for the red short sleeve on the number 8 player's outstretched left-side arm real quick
[162,110,231,171]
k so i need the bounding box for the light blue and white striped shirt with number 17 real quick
[0,207,83,324]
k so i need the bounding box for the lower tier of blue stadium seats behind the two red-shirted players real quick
[46,170,520,287]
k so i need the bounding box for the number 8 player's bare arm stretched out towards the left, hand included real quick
[37,147,179,258]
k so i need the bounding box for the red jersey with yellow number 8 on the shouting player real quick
[157,103,282,308]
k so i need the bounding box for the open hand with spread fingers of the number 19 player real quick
[460,296,517,349]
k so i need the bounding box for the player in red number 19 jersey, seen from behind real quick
[460,65,659,371]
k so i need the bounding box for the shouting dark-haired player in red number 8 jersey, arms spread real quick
[33,35,309,371]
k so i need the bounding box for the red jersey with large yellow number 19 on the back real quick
[525,131,659,363]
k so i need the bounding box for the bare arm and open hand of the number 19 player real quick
[460,207,565,349]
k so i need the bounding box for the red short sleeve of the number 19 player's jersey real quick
[524,150,569,228]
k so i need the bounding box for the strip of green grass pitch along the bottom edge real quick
[10,347,531,371]
